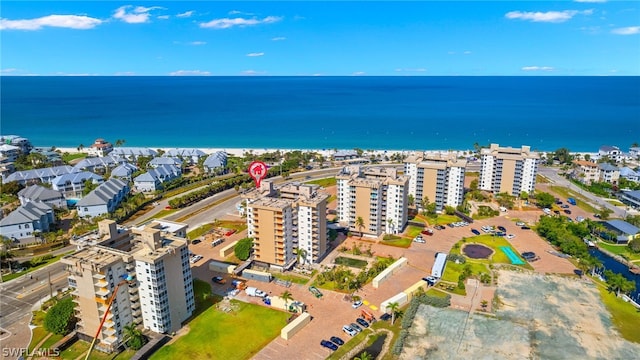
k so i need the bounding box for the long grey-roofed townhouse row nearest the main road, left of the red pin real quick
[76,179,129,217]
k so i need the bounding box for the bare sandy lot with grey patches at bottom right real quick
[400,271,640,360]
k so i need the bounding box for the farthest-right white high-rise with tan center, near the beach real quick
[478,144,540,196]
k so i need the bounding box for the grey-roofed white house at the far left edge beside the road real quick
[0,202,55,241]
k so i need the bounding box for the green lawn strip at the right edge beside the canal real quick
[598,283,640,343]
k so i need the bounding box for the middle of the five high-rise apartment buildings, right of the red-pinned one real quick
[336,166,409,236]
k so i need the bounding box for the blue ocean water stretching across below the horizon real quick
[0,76,640,152]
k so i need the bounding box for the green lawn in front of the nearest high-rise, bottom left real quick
[151,300,289,360]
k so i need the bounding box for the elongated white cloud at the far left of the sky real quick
[0,15,104,30]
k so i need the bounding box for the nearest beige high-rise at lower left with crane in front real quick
[62,220,195,352]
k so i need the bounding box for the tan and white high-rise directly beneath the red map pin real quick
[242,181,329,268]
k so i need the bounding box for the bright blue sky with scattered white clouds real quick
[0,0,640,76]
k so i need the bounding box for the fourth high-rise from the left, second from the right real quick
[404,153,467,211]
